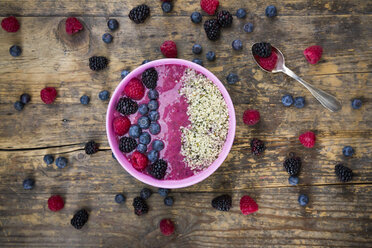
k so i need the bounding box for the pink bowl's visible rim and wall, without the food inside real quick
[106,59,236,189]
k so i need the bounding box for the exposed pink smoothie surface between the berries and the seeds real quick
[114,65,195,180]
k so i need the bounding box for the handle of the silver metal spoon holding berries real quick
[282,67,342,112]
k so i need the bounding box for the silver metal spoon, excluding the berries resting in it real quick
[252,46,342,112]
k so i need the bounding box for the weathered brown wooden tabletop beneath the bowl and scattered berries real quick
[0,0,372,247]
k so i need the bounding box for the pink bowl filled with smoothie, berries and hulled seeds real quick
[106,59,236,189]
